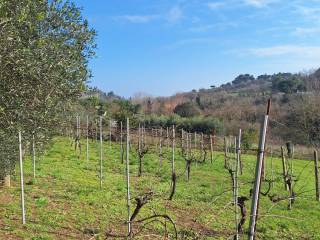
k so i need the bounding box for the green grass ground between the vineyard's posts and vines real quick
[0,138,320,240]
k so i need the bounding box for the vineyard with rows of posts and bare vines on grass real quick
[0,113,320,239]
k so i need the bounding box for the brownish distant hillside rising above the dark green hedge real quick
[132,69,320,142]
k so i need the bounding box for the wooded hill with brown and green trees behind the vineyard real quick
[82,69,320,145]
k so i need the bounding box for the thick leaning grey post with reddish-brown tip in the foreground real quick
[248,99,271,240]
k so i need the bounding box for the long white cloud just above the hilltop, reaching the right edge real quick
[245,45,320,57]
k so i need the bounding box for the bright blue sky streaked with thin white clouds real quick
[75,0,320,97]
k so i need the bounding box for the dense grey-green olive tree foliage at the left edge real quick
[0,0,96,177]
